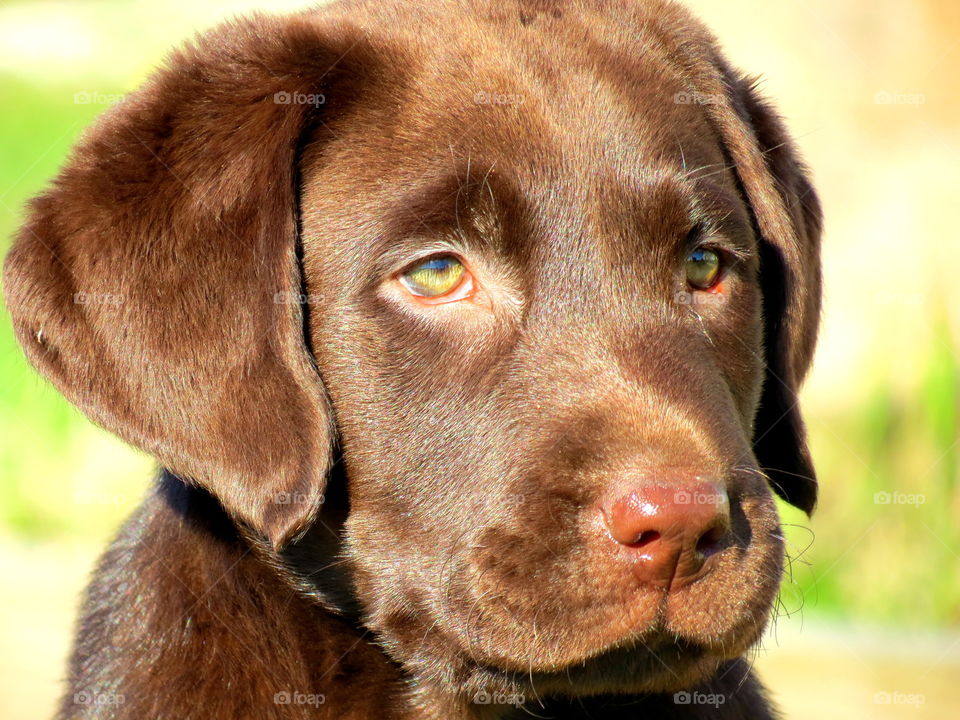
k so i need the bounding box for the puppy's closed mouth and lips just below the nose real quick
[450,548,776,685]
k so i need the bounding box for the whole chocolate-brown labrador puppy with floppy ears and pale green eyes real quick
[5,0,821,720]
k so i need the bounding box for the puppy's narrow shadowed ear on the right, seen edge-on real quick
[701,53,823,514]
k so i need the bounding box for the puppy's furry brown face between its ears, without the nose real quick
[301,57,782,691]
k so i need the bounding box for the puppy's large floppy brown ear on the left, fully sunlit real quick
[5,14,378,547]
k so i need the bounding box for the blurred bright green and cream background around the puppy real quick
[0,0,960,720]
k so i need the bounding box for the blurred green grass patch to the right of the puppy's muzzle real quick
[782,333,960,627]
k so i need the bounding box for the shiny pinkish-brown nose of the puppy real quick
[603,480,730,588]
